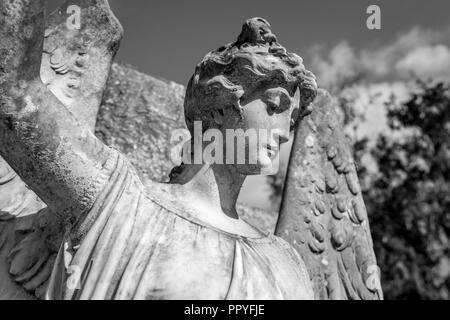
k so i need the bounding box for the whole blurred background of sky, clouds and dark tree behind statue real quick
[49,0,450,299]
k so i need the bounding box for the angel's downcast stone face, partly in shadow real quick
[216,86,300,175]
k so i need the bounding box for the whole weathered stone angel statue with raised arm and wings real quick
[0,0,380,299]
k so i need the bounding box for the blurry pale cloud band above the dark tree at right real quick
[310,27,450,87]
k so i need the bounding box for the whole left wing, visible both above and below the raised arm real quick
[0,0,123,299]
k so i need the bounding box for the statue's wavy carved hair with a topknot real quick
[184,18,317,132]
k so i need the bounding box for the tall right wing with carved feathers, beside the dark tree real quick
[276,90,382,299]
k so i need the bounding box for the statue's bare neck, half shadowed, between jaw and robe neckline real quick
[172,165,246,219]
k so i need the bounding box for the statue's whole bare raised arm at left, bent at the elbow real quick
[0,0,110,219]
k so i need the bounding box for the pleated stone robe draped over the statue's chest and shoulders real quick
[47,150,314,299]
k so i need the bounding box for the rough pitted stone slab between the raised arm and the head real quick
[95,63,186,181]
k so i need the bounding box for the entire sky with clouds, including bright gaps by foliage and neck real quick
[44,0,450,208]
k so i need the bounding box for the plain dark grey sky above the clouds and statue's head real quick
[50,0,450,85]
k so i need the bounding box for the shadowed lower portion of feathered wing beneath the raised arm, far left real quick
[0,162,48,299]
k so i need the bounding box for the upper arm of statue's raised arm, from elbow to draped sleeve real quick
[0,79,110,215]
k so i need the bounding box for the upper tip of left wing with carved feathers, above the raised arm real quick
[41,0,123,129]
